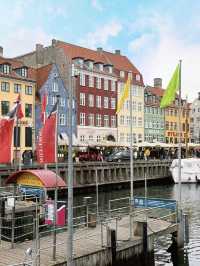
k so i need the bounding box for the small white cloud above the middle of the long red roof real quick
[79,21,122,49]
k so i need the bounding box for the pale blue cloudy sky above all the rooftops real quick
[0,0,200,101]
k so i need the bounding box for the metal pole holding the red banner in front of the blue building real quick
[53,95,60,260]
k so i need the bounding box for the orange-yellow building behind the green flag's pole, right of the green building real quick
[165,99,190,144]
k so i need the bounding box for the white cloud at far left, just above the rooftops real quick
[1,27,53,57]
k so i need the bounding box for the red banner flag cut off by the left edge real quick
[0,118,14,163]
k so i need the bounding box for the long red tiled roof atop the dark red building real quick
[57,41,143,85]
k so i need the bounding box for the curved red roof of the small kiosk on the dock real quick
[6,169,66,188]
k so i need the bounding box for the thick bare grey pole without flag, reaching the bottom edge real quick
[67,62,74,266]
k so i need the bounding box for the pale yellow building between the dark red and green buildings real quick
[117,72,144,145]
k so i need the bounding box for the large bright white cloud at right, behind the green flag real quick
[129,11,200,100]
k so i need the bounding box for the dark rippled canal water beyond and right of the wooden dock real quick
[75,184,200,266]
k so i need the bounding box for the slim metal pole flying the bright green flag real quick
[178,60,182,210]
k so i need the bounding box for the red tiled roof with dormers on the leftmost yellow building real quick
[0,57,36,81]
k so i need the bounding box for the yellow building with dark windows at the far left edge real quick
[0,53,36,162]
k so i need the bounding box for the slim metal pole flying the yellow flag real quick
[130,72,133,204]
